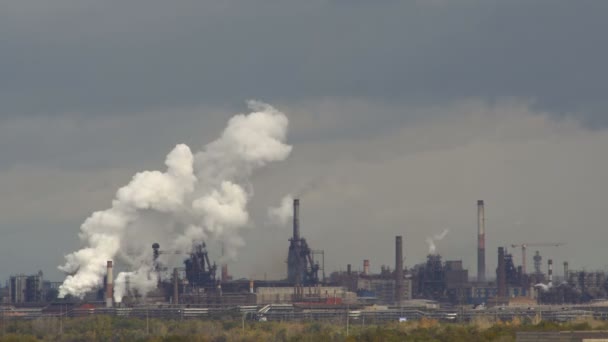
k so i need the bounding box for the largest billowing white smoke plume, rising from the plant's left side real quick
[59,101,292,301]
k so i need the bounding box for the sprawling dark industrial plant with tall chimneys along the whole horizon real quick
[2,199,608,318]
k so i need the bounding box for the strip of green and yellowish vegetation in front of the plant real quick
[0,316,608,342]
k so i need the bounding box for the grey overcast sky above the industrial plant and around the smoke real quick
[0,0,608,280]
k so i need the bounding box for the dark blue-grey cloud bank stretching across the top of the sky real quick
[0,0,608,125]
